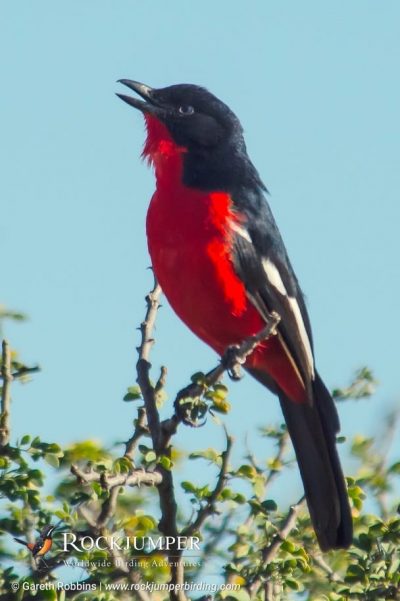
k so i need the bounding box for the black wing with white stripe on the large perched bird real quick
[232,189,315,403]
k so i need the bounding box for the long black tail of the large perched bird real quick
[280,374,353,551]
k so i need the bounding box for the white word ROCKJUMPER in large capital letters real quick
[62,532,200,552]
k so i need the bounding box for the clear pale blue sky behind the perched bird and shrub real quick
[0,0,400,504]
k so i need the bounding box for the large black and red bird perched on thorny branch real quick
[118,79,352,550]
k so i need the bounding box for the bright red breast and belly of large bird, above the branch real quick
[147,189,263,346]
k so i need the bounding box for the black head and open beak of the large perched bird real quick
[118,79,263,191]
